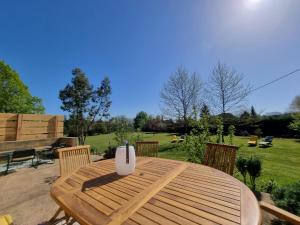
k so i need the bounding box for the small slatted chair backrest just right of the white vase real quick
[135,141,159,157]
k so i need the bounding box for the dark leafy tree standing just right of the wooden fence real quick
[59,68,111,144]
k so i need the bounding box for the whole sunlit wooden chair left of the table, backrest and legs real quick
[49,145,91,224]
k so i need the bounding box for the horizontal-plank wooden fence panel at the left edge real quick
[0,113,64,141]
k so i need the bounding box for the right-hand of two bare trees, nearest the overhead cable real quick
[207,62,251,115]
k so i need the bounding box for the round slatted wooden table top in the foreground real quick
[51,157,261,225]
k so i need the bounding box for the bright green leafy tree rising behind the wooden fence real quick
[0,60,45,114]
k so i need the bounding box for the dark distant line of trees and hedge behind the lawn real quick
[65,112,299,138]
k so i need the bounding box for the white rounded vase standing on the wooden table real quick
[115,146,136,176]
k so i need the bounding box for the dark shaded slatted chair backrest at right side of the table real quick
[204,143,238,175]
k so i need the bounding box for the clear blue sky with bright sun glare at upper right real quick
[0,0,300,117]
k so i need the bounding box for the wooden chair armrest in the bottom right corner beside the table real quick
[260,201,300,225]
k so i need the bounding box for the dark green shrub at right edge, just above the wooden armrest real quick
[271,180,300,216]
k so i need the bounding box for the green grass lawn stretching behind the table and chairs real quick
[87,133,300,185]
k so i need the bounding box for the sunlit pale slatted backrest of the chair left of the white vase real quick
[58,145,91,176]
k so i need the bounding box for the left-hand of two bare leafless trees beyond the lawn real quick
[160,67,202,129]
